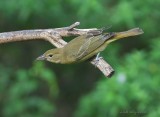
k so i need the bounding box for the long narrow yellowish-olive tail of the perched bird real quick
[108,28,143,43]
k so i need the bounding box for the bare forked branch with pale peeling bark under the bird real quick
[0,22,114,77]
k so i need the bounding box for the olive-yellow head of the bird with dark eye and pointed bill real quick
[36,48,62,63]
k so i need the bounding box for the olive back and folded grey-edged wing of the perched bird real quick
[64,34,111,61]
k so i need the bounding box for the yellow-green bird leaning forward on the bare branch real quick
[37,28,143,64]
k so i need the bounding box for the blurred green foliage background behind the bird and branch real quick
[0,0,160,117]
